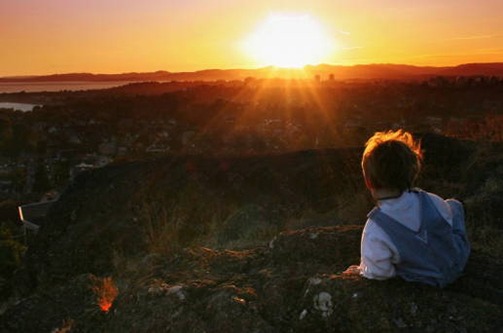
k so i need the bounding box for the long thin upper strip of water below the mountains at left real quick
[0,81,132,93]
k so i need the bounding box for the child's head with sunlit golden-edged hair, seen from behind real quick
[362,130,422,191]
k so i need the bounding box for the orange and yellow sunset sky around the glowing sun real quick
[0,0,503,76]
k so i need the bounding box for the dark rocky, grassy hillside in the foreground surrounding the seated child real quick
[0,134,503,332]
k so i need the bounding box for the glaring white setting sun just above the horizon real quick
[244,14,333,68]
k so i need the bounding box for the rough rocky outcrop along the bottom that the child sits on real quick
[0,227,503,333]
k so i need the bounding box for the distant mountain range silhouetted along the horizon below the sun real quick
[0,62,503,82]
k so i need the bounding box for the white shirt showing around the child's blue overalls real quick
[359,191,452,280]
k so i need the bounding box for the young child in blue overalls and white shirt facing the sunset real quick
[345,130,470,287]
